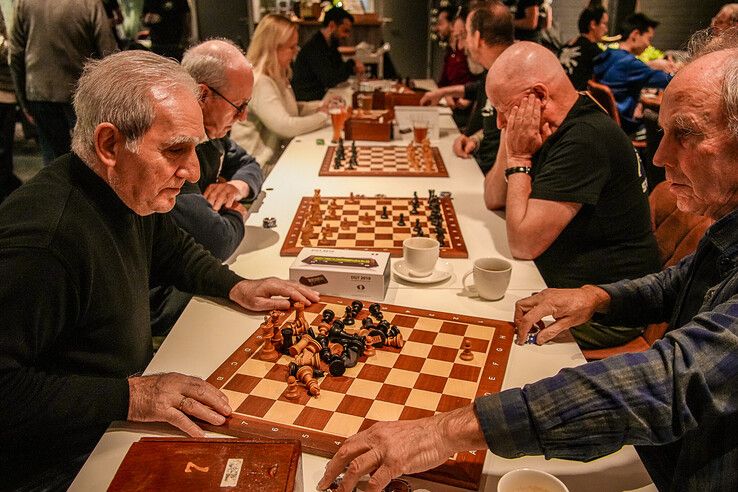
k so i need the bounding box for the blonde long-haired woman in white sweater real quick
[231,14,330,175]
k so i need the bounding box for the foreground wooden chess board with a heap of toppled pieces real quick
[201,296,513,490]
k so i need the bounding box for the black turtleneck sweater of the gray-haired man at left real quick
[0,155,241,488]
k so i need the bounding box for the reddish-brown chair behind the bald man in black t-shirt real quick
[582,182,712,360]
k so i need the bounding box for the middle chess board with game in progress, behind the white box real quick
[280,196,469,258]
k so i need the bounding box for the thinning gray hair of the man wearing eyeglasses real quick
[182,38,246,89]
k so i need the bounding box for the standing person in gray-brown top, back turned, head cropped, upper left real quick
[9,0,118,164]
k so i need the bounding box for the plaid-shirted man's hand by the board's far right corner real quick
[514,285,610,345]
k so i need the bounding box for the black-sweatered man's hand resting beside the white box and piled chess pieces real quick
[228,277,320,311]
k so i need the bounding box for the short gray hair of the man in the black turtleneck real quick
[72,50,199,167]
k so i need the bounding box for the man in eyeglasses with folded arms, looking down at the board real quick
[150,39,264,335]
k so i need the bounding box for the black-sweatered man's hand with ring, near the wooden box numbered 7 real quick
[128,373,231,437]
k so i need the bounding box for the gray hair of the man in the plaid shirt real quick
[688,27,738,139]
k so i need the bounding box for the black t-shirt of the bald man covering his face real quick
[530,96,661,288]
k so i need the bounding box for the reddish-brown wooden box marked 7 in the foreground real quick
[108,437,303,492]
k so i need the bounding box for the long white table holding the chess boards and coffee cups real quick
[71,108,650,492]
